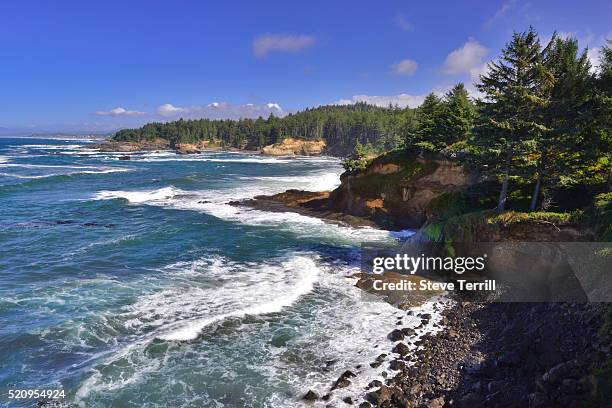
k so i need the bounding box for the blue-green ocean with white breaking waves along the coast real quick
[0,138,440,407]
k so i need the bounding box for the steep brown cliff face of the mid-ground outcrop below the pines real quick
[329,152,472,228]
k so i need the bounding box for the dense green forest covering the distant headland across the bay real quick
[113,103,416,155]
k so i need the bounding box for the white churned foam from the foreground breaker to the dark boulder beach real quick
[71,253,443,407]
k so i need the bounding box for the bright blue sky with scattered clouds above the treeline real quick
[0,0,612,131]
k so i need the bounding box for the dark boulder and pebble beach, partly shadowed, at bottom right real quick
[303,299,609,408]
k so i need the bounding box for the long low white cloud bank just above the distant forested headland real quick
[156,102,285,119]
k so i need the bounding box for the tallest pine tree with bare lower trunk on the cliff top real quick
[477,28,550,212]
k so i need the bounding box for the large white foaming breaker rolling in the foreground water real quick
[71,254,320,402]
